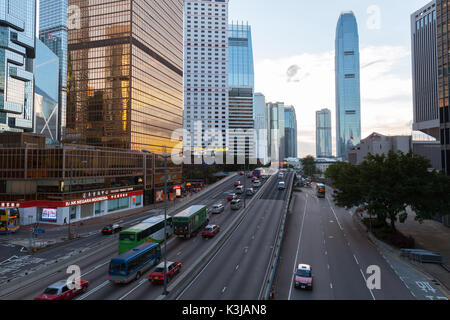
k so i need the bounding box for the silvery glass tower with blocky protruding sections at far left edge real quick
[0,0,36,132]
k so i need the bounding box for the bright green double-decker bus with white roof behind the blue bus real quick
[119,216,173,254]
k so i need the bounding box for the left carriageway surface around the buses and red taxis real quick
[0,172,270,300]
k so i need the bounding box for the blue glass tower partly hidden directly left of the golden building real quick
[39,0,68,140]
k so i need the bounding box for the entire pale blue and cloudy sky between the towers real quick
[229,0,429,157]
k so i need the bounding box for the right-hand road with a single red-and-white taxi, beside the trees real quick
[275,184,444,300]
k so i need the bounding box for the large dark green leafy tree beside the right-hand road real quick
[326,152,450,232]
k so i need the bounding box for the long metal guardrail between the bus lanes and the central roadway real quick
[157,174,276,300]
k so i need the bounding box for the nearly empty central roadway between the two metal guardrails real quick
[178,174,293,300]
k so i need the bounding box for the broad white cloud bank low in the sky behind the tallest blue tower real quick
[255,46,413,156]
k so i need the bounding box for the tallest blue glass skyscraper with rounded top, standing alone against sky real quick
[336,11,361,160]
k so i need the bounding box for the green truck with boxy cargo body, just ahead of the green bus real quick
[173,205,209,239]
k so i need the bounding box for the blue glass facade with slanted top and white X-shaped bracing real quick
[33,39,60,144]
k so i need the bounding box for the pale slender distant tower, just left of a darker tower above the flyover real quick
[267,102,286,165]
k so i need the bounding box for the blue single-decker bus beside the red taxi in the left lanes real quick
[108,243,161,284]
